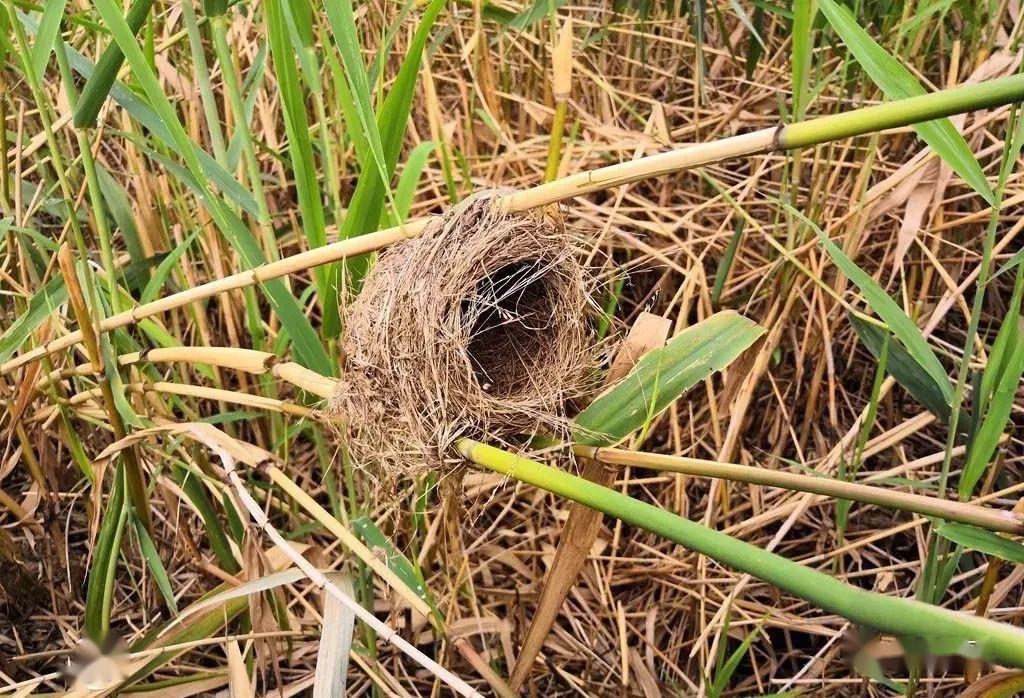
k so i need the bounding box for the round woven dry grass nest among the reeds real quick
[331,194,594,476]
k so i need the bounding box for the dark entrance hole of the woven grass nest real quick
[462,260,558,398]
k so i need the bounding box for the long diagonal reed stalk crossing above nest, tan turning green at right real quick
[6,75,1024,375]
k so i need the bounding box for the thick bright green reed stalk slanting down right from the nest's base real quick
[458,439,1024,666]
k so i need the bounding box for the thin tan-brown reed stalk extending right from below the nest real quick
[574,446,1024,535]
